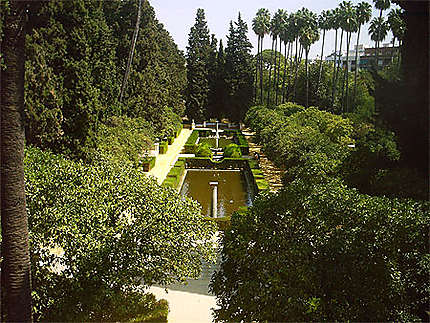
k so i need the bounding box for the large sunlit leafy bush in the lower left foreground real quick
[24,148,215,321]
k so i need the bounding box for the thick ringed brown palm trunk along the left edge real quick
[0,0,32,322]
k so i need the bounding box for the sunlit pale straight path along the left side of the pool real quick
[149,129,192,184]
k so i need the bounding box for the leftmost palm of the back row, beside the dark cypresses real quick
[252,8,270,104]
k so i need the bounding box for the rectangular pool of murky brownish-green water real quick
[181,169,252,217]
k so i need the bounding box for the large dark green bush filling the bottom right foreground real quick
[211,180,430,322]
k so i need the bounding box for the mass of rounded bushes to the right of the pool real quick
[212,104,430,321]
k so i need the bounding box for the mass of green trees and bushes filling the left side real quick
[0,0,215,322]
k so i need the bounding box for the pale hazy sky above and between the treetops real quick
[150,0,393,57]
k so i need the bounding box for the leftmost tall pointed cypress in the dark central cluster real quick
[187,9,210,120]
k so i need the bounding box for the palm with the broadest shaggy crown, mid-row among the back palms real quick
[299,8,320,107]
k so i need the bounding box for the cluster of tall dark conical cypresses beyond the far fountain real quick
[186,9,253,121]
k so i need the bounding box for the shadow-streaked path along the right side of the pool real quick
[242,129,284,192]
